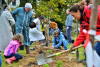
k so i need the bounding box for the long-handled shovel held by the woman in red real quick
[36,45,83,65]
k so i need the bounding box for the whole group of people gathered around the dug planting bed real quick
[0,1,100,67]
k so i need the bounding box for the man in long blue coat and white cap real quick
[12,3,33,54]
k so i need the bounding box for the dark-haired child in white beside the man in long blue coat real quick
[29,22,45,44]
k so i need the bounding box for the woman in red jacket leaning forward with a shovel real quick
[70,1,100,50]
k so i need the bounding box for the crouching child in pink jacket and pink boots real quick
[4,34,23,64]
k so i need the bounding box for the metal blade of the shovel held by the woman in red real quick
[36,53,53,65]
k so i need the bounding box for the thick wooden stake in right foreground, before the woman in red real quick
[89,0,99,49]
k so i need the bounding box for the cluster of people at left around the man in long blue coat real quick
[0,3,45,67]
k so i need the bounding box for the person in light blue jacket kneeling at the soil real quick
[51,30,68,50]
